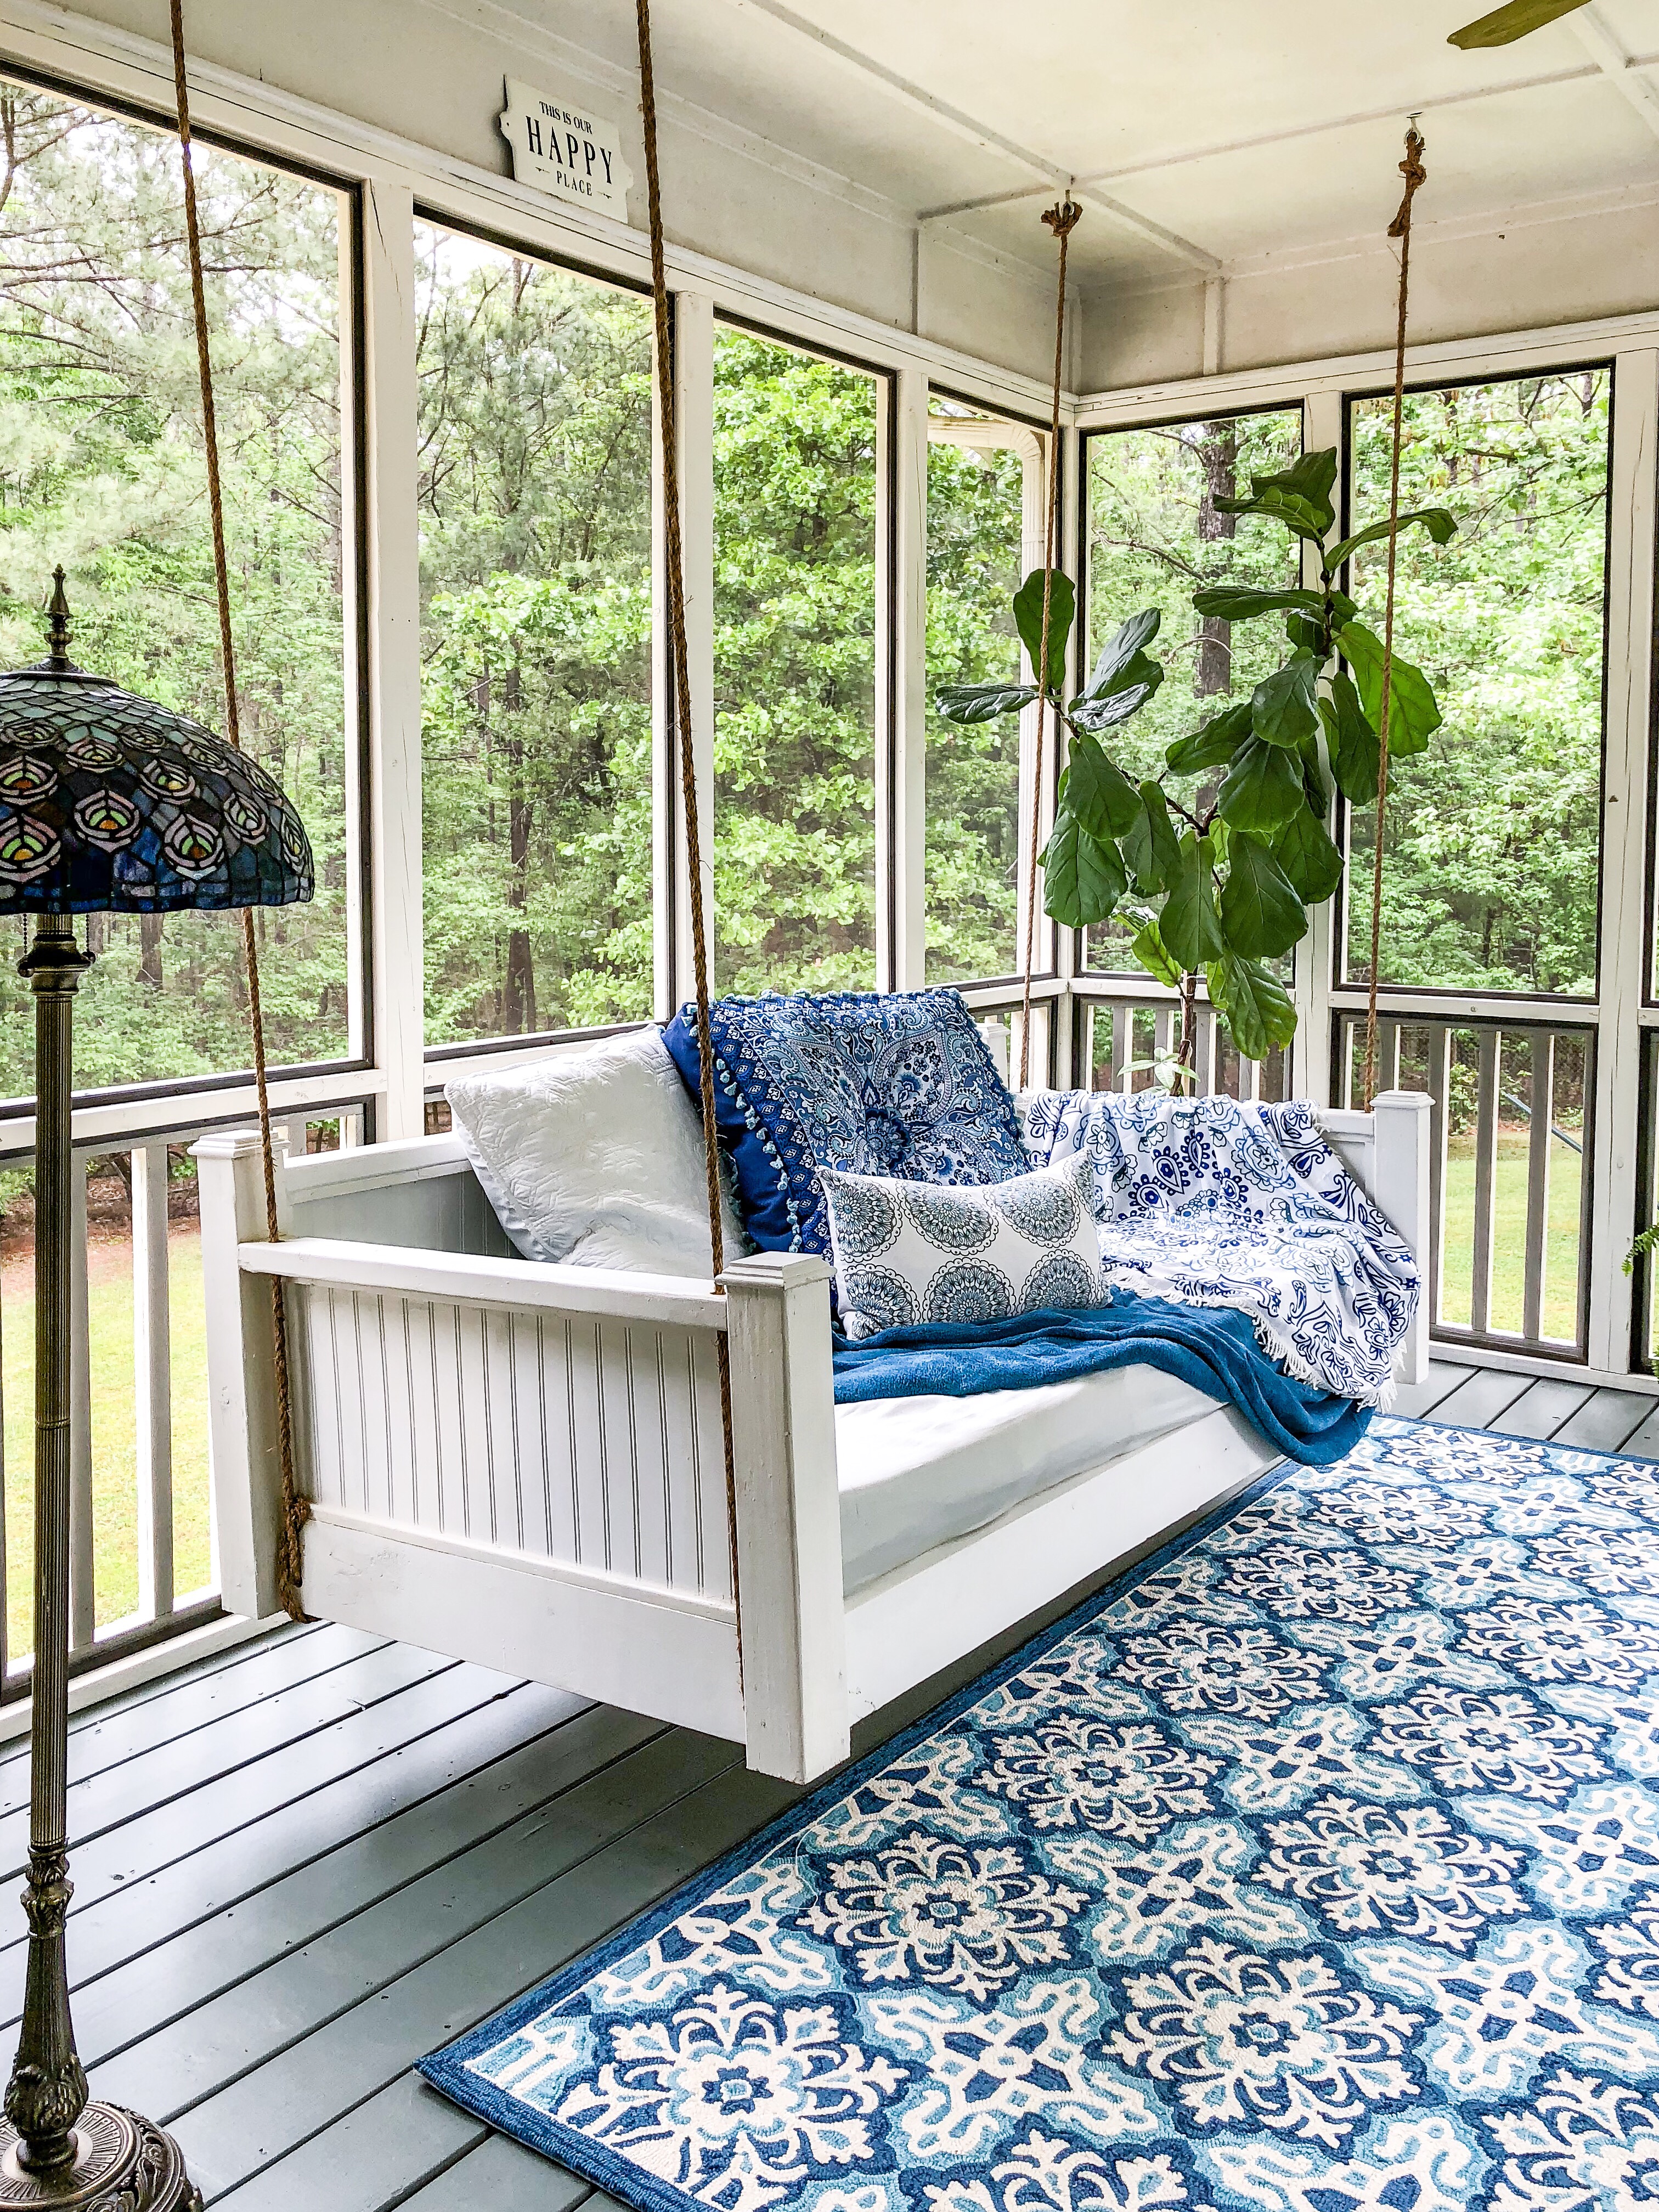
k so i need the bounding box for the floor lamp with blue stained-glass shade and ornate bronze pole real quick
[0,568,312,2212]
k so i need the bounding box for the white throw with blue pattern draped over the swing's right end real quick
[1015,1091,1420,1409]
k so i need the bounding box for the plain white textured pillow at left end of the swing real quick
[444,1029,748,1276]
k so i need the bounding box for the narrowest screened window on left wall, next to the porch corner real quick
[927,396,1044,982]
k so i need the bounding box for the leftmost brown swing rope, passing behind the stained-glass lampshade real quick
[170,0,312,1621]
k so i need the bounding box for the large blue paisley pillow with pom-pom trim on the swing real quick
[664,991,1031,1259]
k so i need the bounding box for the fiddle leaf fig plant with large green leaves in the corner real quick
[936,447,1458,1082]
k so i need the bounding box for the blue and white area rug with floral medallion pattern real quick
[425,1420,1659,2212]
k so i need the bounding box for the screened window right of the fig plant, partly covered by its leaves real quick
[1347,367,1612,995]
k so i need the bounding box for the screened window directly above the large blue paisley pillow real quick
[714,330,887,993]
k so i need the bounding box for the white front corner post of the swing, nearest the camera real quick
[721,1252,849,1781]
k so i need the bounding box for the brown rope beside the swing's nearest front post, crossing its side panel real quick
[637,0,743,1654]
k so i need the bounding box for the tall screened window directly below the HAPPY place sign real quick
[416,223,652,1044]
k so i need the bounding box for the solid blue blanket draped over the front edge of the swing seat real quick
[834,1290,1372,1466]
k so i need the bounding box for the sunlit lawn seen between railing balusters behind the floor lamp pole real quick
[0,1221,212,1659]
